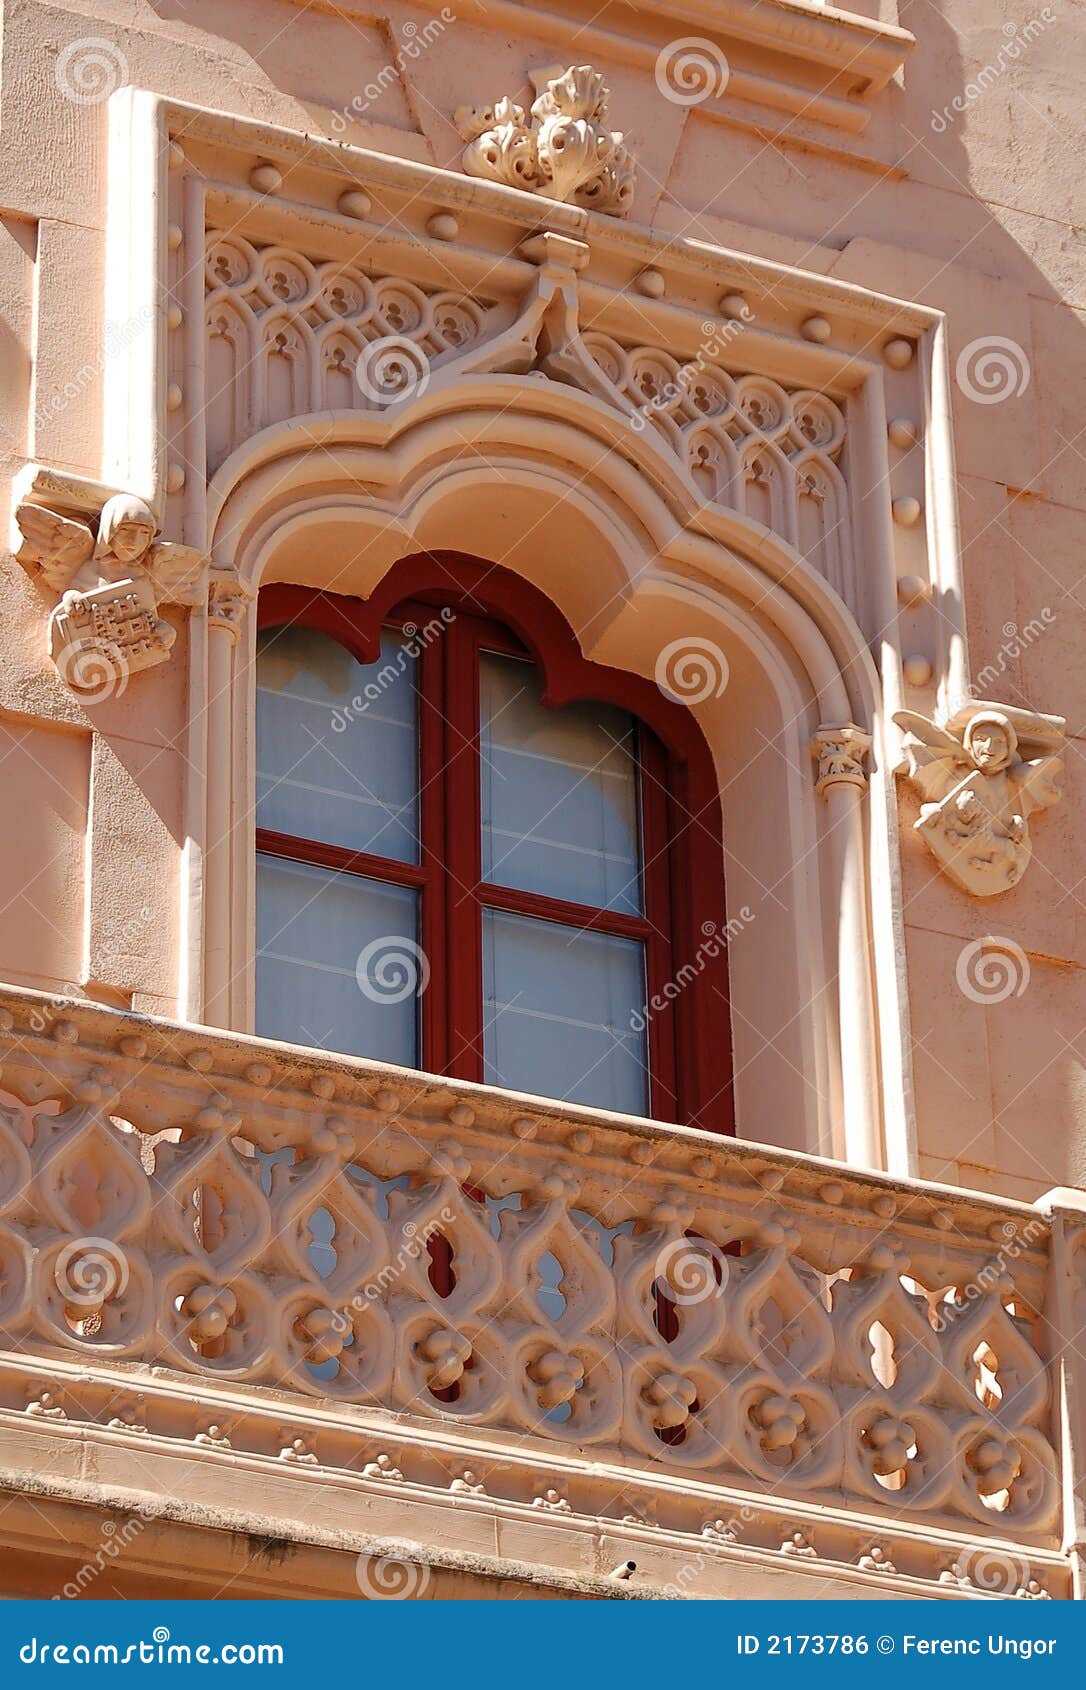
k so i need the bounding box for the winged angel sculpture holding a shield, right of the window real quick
[893,710,1062,897]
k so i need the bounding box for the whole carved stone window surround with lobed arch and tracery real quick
[30,90,986,1173]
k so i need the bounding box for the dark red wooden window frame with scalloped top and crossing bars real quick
[255,553,735,1132]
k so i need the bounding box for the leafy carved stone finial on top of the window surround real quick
[453,64,637,216]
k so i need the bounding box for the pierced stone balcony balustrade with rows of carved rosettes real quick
[0,989,1057,1543]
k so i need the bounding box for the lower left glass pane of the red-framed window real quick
[257,855,426,1068]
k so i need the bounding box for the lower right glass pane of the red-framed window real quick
[483,909,647,1115]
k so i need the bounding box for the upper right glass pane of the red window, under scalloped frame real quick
[480,656,642,914]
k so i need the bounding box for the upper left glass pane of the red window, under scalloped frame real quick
[257,627,419,862]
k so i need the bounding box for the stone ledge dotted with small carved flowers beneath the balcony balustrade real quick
[0,1357,1069,1600]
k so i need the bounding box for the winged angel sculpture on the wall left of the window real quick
[15,493,206,696]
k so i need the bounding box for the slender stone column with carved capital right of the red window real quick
[811,722,885,1169]
